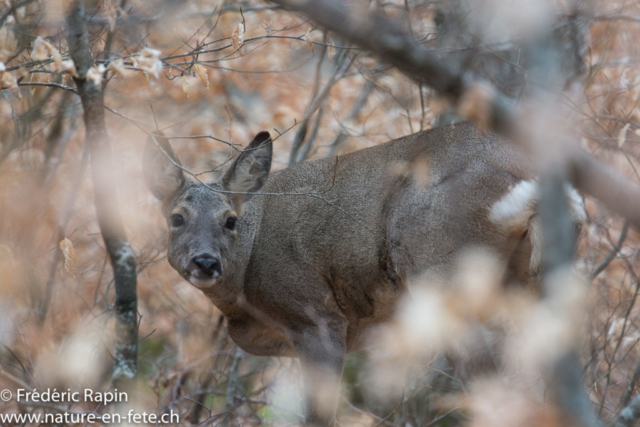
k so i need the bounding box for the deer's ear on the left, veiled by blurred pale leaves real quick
[142,131,185,201]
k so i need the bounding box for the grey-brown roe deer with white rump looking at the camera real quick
[144,123,585,425]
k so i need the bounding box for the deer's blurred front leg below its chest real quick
[296,324,346,427]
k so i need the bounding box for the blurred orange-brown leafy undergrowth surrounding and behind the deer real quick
[0,0,640,426]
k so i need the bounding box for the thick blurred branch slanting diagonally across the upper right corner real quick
[272,0,640,228]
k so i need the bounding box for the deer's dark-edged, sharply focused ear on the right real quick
[221,132,273,210]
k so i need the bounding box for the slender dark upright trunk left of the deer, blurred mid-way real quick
[67,0,138,394]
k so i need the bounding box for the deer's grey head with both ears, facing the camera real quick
[143,132,272,288]
